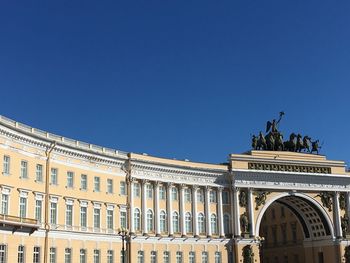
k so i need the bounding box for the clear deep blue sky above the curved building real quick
[0,0,350,166]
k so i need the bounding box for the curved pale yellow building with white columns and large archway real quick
[0,117,350,263]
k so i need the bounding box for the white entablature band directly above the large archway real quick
[232,170,350,192]
